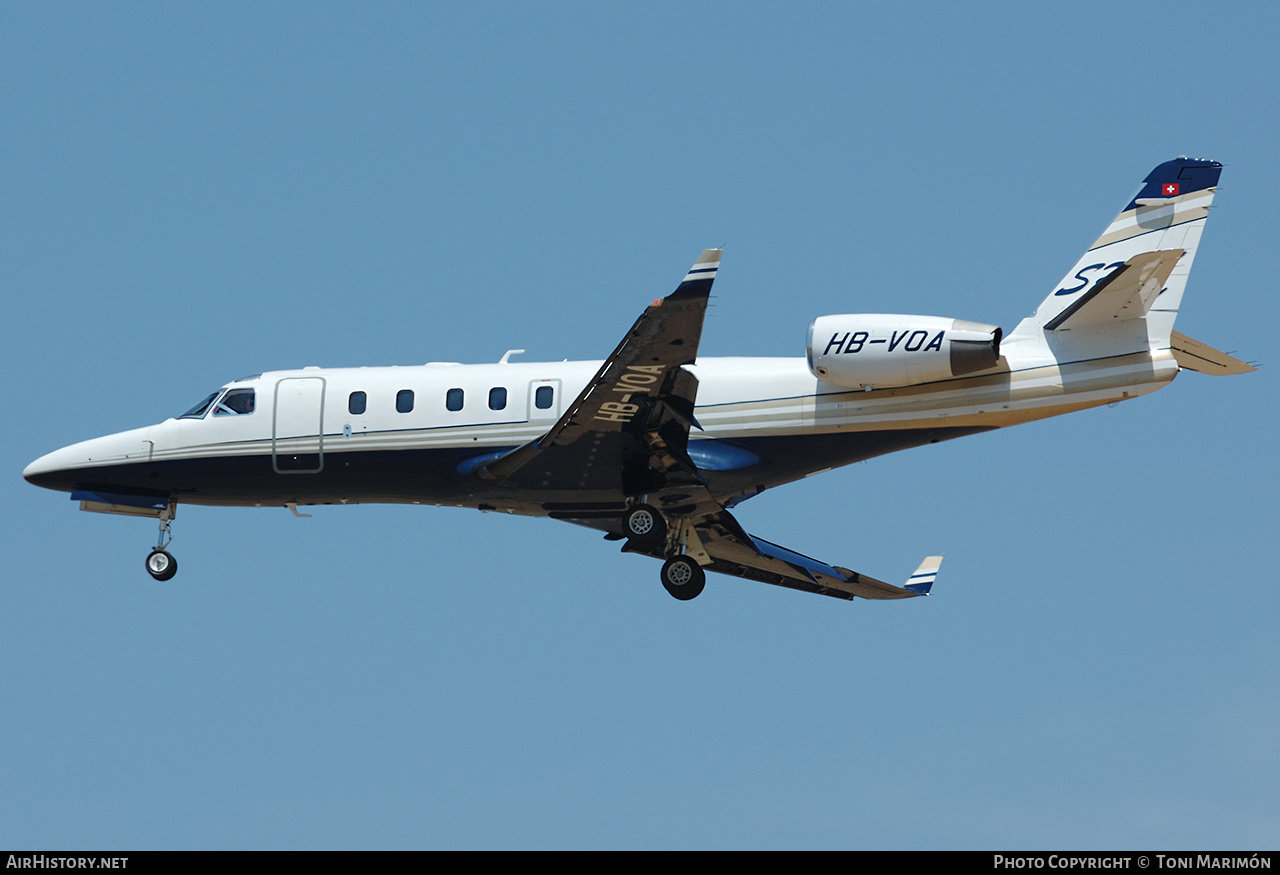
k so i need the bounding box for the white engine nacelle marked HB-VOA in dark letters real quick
[805,313,1004,389]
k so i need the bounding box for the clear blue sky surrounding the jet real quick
[0,3,1280,848]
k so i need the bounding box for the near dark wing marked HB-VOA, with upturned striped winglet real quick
[475,249,721,501]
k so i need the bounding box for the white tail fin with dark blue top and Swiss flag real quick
[1011,157,1222,349]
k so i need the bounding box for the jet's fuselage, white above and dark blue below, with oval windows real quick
[24,343,1178,513]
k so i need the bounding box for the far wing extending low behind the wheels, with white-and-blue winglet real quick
[629,510,942,600]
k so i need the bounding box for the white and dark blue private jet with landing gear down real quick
[23,157,1254,600]
